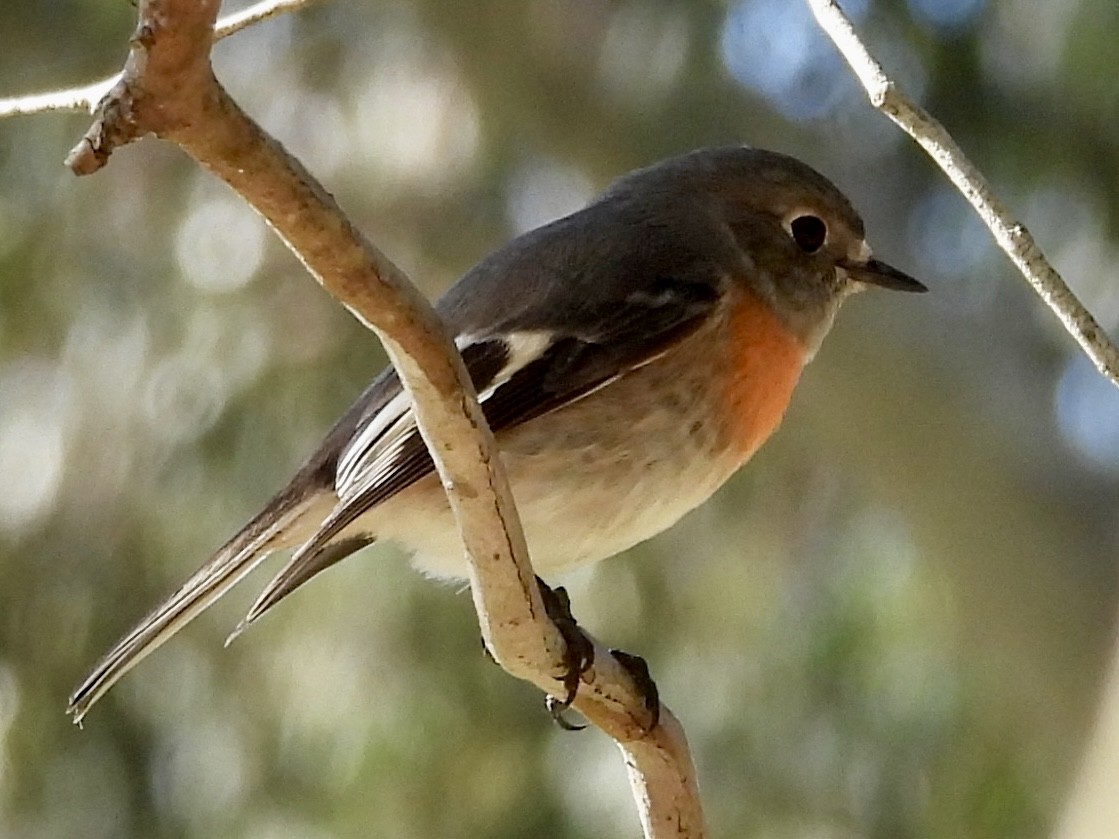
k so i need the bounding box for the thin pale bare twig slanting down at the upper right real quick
[807,0,1119,386]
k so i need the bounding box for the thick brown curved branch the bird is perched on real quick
[61,0,703,839]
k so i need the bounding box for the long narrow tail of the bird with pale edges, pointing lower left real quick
[67,488,336,723]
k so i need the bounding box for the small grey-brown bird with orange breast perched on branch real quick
[68,145,925,723]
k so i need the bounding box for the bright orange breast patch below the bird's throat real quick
[723,294,806,461]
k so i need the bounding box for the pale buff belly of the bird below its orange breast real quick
[363,308,799,577]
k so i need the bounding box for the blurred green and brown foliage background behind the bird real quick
[0,0,1119,839]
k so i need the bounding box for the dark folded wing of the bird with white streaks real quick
[238,277,718,631]
